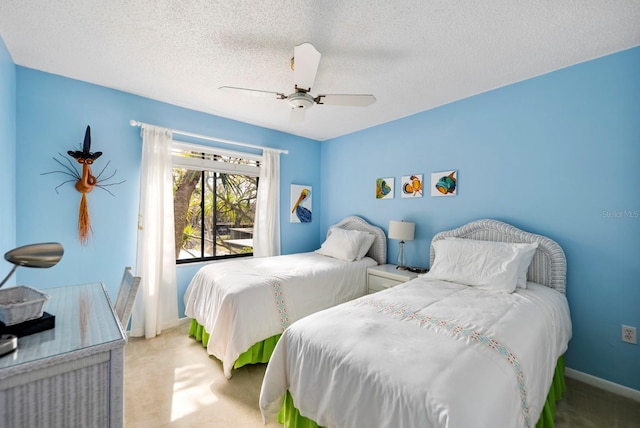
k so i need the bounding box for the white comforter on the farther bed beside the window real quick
[184,252,376,378]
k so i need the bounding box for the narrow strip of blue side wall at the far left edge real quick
[0,37,16,278]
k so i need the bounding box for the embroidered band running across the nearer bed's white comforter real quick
[355,298,531,427]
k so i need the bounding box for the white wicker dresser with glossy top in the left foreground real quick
[0,283,126,428]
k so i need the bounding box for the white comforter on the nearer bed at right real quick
[260,278,571,428]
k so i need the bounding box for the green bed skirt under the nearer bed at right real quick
[278,355,567,428]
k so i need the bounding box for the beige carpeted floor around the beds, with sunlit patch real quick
[125,324,640,428]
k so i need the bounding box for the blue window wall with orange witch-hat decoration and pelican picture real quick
[10,67,320,316]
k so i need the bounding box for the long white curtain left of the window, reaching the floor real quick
[131,125,178,339]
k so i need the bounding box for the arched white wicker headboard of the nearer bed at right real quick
[429,220,567,293]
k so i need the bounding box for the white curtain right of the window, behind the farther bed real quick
[253,149,280,257]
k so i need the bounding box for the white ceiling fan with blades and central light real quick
[218,43,376,122]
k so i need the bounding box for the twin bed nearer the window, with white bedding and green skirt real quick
[184,216,387,378]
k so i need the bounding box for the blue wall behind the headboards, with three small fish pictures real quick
[321,48,640,390]
